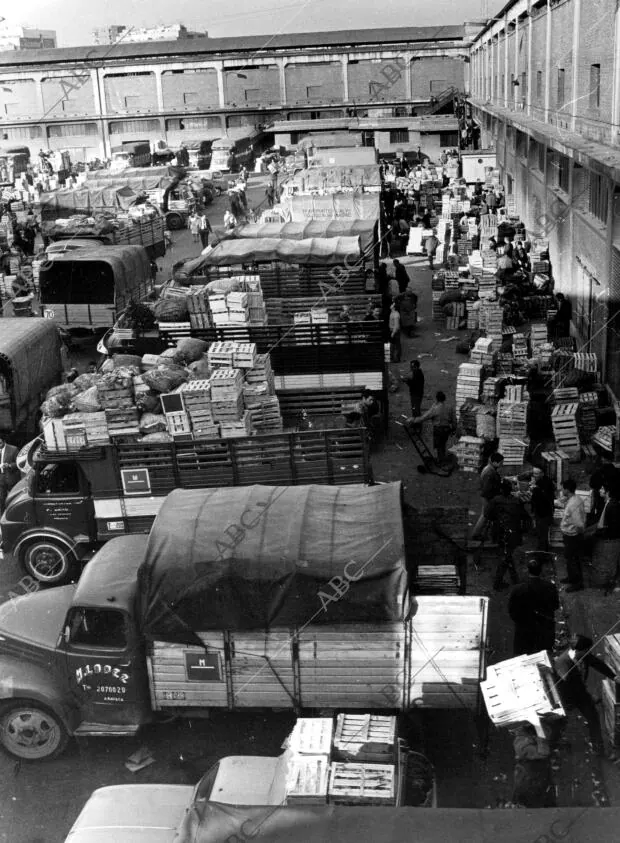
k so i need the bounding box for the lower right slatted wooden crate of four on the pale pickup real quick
[328,761,396,806]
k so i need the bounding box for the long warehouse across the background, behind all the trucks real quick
[0,24,480,160]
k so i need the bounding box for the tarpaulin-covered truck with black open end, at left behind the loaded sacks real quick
[39,246,153,333]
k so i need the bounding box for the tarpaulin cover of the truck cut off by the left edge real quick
[0,317,62,421]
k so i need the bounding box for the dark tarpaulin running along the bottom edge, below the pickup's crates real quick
[175,800,620,843]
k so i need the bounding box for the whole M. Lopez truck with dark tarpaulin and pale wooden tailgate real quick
[0,483,488,760]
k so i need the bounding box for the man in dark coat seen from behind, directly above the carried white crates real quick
[508,559,560,656]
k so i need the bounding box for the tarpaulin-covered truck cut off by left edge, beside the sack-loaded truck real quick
[0,317,63,443]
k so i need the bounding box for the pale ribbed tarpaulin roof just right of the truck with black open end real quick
[182,237,361,275]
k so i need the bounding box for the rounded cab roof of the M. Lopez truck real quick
[73,535,148,614]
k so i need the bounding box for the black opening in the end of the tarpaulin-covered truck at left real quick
[40,261,114,304]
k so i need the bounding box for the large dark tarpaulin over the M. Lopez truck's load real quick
[138,483,407,642]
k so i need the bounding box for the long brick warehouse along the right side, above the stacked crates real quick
[471,0,620,397]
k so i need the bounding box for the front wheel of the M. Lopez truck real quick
[0,700,69,761]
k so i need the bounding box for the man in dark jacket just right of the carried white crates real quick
[553,635,620,755]
